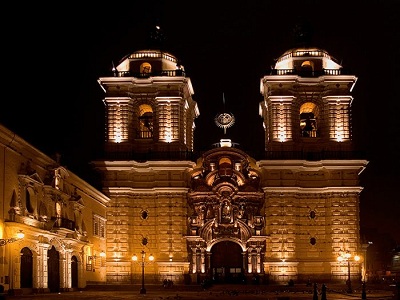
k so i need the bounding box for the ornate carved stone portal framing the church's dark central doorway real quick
[187,143,265,275]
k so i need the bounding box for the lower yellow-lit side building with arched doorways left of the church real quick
[0,125,109,295]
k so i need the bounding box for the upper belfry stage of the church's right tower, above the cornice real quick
[260,46,357,158]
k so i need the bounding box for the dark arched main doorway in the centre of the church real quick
[211,241,245,283]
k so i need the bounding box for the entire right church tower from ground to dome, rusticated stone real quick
[259,47,367,280]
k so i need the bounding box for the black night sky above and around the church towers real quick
[0,0,400,244]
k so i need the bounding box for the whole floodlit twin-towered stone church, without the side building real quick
[94,48,368,283]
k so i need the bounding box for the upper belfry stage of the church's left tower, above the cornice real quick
[98,27,199,158]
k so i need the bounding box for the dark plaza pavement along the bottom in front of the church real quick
[0,285,400,300]
